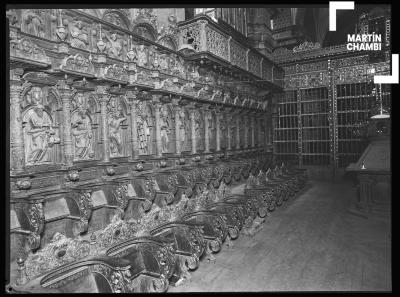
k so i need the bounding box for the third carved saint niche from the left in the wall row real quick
[107,96,128,158]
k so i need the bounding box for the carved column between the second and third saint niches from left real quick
[96,86,110,162]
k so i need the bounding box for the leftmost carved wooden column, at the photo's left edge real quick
[10,69,25,173]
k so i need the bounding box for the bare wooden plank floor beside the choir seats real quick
[168,182,392,292]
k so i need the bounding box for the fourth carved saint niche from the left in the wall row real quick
[136,101,154,155]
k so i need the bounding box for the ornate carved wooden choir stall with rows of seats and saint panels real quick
[7,9,306,293]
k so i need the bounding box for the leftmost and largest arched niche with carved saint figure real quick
[22,85,61,165]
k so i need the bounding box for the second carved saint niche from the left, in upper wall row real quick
[71,92,99,160]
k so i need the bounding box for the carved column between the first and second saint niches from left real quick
[57,80,74,166]
